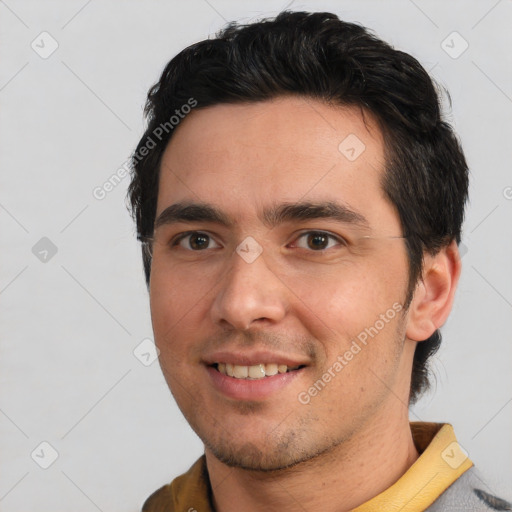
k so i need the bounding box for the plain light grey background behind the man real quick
[0,0,512,512]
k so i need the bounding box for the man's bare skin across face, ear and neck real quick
[150,97,460,512]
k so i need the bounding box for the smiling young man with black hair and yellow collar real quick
[129,12,512,512]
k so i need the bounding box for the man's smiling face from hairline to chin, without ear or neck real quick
[150,97,412,470]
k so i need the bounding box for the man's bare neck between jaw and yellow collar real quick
[205,407,419,512]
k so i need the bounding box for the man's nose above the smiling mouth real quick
[211,246,288,330]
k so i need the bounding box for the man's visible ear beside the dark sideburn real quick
[406,240,462,341]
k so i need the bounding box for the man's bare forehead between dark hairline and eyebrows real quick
[157,97,389,228]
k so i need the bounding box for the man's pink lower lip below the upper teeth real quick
[206,366,304,400]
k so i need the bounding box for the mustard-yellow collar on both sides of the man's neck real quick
[142,422,473,512]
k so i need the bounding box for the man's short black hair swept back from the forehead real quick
[128,11,468,403]
